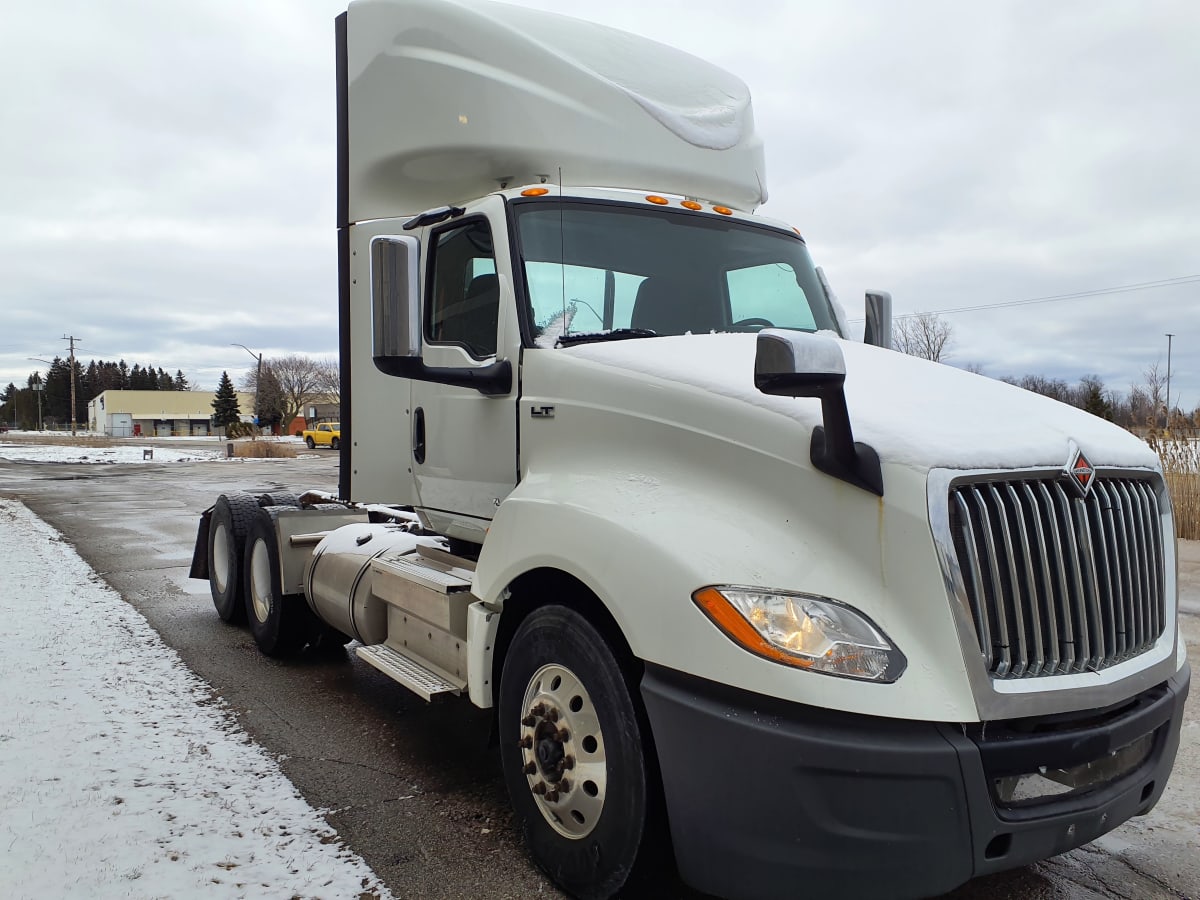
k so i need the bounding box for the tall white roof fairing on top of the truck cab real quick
[347,0,766,222]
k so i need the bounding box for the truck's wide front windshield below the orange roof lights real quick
[514,200,838,347]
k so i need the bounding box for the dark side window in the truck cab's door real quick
[425,218,500,359]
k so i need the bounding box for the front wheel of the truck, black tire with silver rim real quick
[499,606,649,898]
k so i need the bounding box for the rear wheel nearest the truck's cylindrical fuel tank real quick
[242,506,316,656]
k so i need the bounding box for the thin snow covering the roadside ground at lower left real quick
[0,499,390,900]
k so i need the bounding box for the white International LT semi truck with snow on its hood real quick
[192,0,1189,898]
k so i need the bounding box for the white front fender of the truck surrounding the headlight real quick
[473,470,976,721]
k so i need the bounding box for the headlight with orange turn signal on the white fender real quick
[691,587,907,684]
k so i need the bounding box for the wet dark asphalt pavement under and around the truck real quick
[0,454,1200,900]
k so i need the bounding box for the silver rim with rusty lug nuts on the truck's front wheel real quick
[520,665,608,840]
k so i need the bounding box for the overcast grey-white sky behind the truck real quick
[0,0,1200,409]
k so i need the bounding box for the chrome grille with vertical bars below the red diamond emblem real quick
[949,475,1166,678]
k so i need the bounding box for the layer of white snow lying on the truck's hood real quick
[562,335,1158,470]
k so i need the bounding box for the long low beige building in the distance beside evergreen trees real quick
[88,390,254,438]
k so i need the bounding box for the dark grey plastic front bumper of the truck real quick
[642,665,1190,898]
